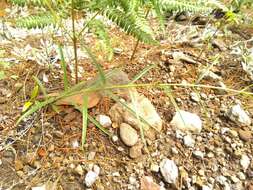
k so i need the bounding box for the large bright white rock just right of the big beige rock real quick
[170,110,202,133]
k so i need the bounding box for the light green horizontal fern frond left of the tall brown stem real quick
[16,13,56,29]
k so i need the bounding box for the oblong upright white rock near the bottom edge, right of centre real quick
[160,159,178,183]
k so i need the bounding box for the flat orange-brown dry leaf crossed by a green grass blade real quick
[55,92,101,108]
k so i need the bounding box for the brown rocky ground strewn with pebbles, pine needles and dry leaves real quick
[0,1,253,190]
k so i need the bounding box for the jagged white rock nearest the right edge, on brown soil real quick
[227,104,251,126]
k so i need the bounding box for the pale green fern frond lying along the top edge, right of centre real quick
[159,0,212,12]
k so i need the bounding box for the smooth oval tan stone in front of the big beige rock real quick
[119,123,138,146]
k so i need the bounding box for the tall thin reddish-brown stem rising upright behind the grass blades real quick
[71,0,78,84]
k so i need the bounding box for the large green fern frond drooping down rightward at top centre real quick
[104,8,157,44]
